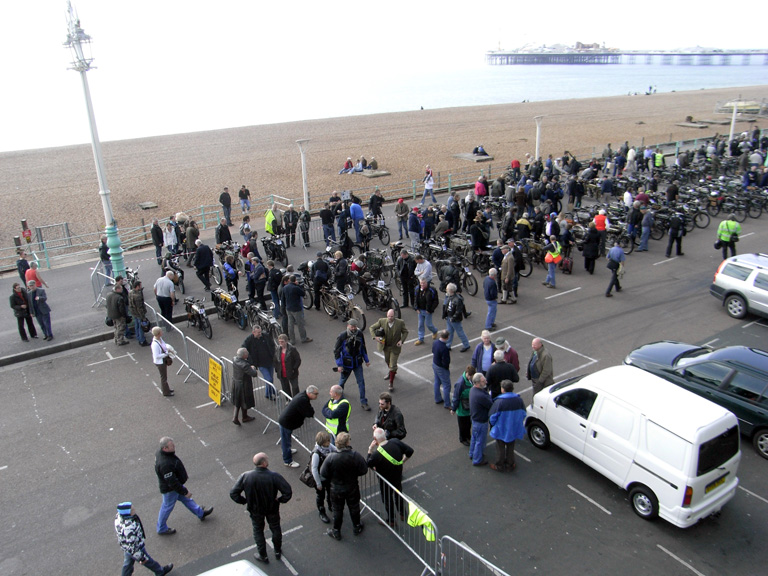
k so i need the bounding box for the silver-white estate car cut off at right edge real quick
[709,254,768,319]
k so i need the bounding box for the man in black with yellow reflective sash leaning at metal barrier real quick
[366,428,413,527]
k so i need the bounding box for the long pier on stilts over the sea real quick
[485,50,768,66]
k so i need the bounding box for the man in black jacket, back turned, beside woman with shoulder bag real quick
[320,432,368,540]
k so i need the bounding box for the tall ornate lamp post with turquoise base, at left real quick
[64,2,125,277]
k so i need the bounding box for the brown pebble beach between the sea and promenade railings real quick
[0,86,768,246]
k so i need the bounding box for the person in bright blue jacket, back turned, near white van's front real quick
[489,380,525,472]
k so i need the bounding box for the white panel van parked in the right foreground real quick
[525,366,741,528]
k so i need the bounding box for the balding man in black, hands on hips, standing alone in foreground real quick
[229,452,293,564]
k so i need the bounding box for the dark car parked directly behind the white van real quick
[624,340,768,459]
